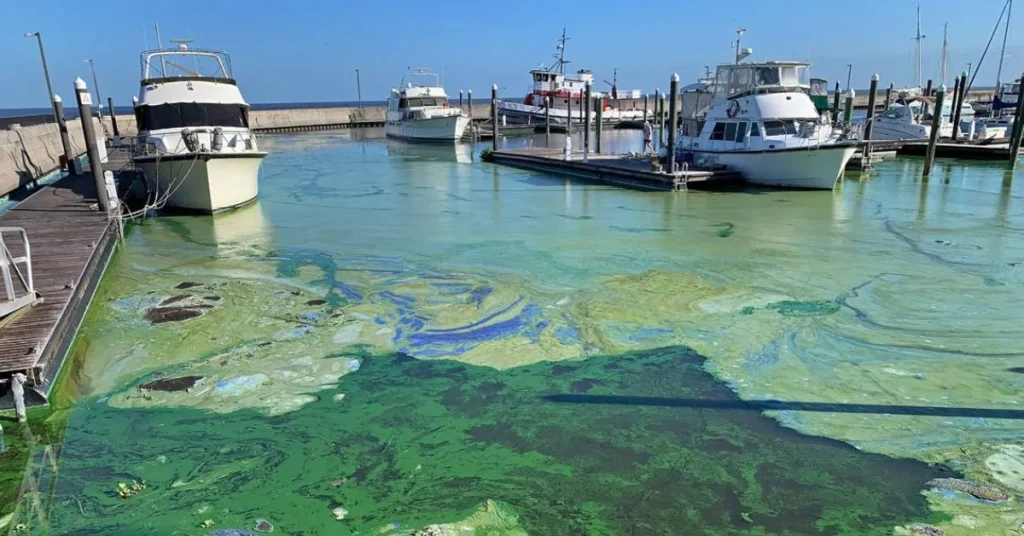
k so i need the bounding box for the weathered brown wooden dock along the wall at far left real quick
[0,151,120,408]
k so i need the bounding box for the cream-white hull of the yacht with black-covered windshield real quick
[135,153,266,214]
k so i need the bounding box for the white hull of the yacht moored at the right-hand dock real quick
[680,145,857,190]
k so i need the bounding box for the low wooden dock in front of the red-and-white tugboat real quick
[490,149,740,191]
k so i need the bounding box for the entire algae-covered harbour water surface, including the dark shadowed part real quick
[3,131,1024,536]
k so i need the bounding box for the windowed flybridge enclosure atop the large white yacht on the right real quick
[715,61,810,100]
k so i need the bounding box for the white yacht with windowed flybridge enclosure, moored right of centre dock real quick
[676,61,857,190]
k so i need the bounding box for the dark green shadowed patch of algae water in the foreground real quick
[39,346,950,535]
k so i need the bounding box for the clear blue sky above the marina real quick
[0,0,1024,108]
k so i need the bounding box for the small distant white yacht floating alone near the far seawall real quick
[384,69,470,141]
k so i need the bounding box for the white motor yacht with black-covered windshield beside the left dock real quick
[132,41,266,213]
